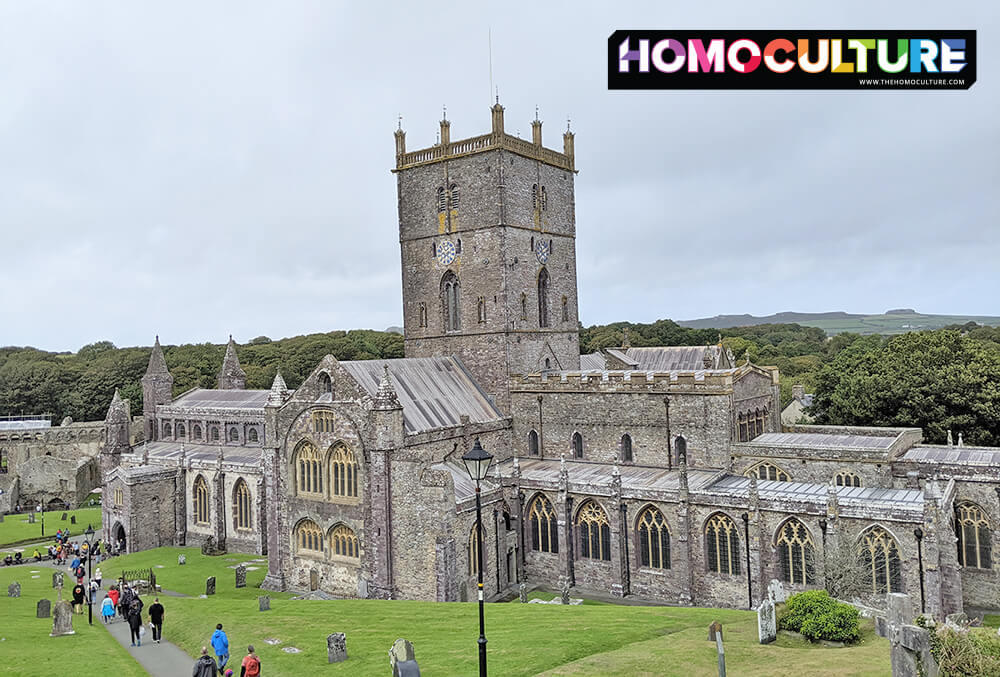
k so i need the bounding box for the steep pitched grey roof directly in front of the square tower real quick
[340,357,504,433]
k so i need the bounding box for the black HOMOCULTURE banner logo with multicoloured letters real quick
[608,30,976,90]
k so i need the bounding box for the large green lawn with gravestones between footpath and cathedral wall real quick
[102,548,891,677]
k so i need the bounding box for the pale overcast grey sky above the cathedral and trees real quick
[0,0,1000,350]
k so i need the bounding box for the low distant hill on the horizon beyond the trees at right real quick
[677,308,1000,335]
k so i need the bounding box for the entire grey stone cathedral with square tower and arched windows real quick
[100,104,1000,615]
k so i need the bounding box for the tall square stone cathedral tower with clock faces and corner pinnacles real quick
[393,103,580,412]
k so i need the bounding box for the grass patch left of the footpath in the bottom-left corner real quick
[0,568,146,677]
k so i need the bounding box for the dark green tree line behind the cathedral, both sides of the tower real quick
[0,320,1000,446]
